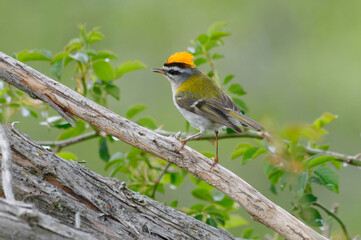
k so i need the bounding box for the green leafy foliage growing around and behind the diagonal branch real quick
[0,22,349,239]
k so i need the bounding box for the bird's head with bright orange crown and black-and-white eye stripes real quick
[153,52,199,85]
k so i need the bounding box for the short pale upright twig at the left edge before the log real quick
[0,124,15,202]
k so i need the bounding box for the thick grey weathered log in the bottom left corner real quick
[0,125,234,240]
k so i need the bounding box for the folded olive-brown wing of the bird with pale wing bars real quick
[175,91,242,132]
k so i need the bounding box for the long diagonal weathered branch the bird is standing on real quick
[0,52,326,240]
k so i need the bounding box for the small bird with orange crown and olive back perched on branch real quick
[153,52,263,167]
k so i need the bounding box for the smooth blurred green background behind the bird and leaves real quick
[0,0,361,238]
